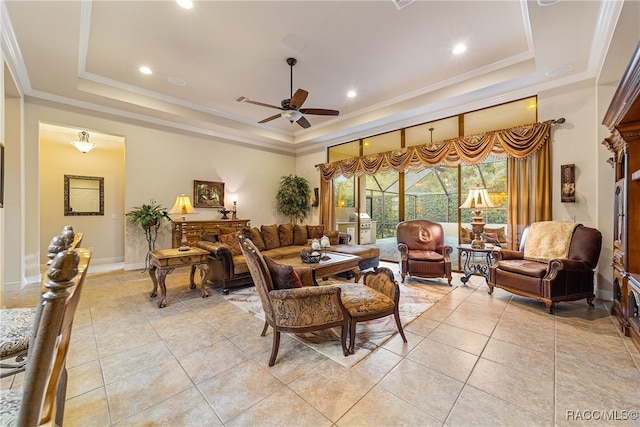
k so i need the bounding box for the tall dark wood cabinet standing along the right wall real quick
[603,43,640,349]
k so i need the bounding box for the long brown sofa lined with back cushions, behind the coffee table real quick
[196,224,380,293]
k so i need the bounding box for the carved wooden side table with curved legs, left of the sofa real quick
[149,248,209,308]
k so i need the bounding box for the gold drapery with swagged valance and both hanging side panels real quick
[318,120,555,249]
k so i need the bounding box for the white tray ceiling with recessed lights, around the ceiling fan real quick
[1,0,622,152]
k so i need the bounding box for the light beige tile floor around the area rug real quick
[2,266,640,427]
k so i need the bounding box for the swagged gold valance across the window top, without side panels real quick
[318,120,556,181]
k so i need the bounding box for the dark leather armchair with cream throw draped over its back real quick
[488,221,602,313]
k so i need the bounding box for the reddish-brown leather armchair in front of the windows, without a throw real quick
[396,219,452,286]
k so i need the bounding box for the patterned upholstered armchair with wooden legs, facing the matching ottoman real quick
[239,236,349,366]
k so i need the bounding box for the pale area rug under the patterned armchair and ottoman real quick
[225,270,455,367]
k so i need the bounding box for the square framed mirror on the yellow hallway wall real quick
[64,175,104,216]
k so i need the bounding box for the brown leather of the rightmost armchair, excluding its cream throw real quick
[488,224,602,313]
